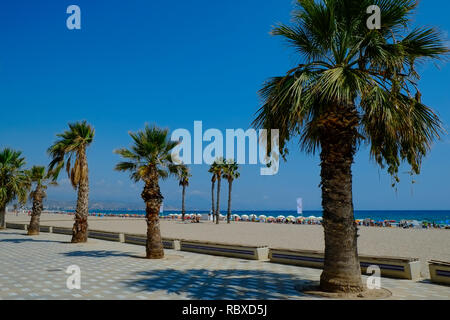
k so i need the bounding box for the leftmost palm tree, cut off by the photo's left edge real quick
[0,148,30,229]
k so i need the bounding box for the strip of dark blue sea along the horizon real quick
[84,210,450,225]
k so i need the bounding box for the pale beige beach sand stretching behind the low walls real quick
[6,213,450,277]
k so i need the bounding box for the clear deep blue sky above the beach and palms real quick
[0,0,450,210]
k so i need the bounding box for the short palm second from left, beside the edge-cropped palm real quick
[27,166,56,236]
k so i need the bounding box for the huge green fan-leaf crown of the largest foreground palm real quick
[255,0,448,180]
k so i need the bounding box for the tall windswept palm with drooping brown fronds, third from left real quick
[47,121,95,243]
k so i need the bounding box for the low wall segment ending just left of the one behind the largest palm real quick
[181,240,269,260]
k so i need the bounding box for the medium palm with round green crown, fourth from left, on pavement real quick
[114,126,178,259]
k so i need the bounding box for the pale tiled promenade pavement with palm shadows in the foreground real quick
[0,230,450,300]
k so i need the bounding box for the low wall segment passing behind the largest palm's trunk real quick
[269,249,420,280]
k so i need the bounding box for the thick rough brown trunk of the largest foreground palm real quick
[320,108,364,293]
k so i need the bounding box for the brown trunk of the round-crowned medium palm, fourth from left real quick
[141,166,164,259]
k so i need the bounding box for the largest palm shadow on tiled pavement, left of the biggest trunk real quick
[122,269,315,300]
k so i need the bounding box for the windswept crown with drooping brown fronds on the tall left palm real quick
[48,121,95,189]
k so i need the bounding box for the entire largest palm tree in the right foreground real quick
[254,0,449,292]
